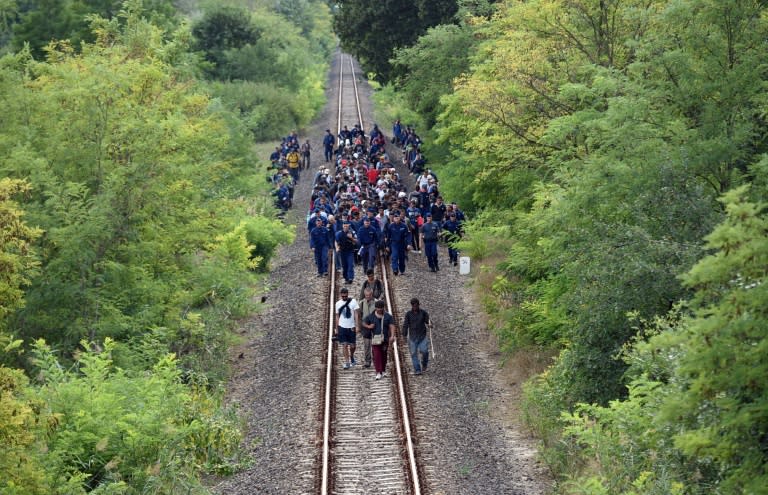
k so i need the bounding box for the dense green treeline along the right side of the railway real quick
[340,0,768,495]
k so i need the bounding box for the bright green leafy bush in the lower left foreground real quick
[28,340,241,494]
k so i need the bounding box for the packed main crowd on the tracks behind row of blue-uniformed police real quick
[307,122,465,284]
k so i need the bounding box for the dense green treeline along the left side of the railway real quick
[0,0,333,495]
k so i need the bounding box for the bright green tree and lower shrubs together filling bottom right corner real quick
[563,187,768,494]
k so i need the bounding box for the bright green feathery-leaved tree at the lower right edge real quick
[658,187,768,493]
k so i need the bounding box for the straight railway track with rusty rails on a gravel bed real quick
[316,56,426,495]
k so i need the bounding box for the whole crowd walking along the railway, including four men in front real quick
[270,121,465,380]
